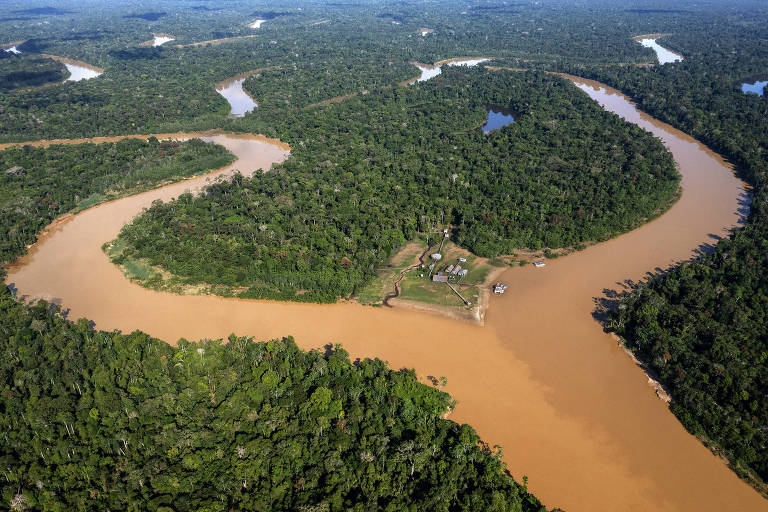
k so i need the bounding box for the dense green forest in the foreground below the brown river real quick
[0,288,545,512]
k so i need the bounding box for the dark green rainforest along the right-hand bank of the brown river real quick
[576,16,768,494]
